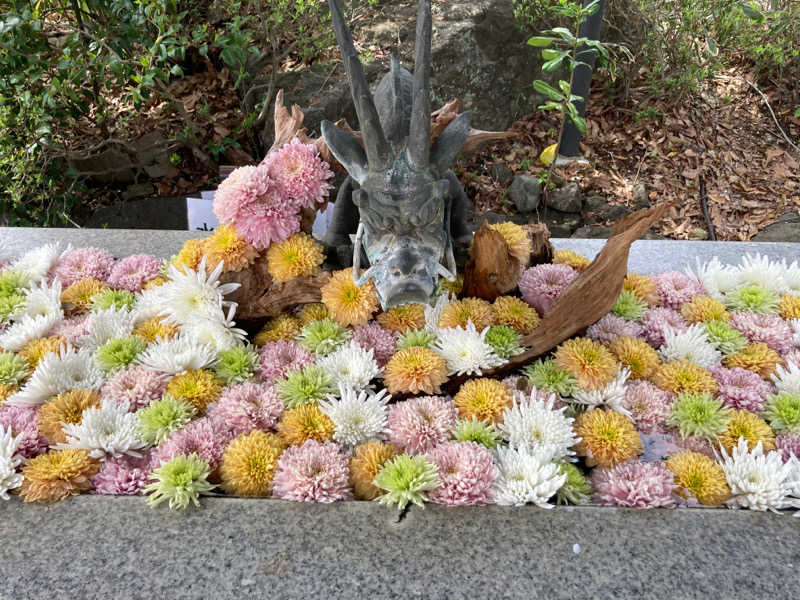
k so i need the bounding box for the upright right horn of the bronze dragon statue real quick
[408,0,431,167]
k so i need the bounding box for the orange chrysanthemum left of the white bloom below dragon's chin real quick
[383,346,447,394]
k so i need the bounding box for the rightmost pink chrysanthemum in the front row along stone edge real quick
[592,460,676,508]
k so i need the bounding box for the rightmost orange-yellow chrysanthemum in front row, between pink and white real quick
[664,450,731,506]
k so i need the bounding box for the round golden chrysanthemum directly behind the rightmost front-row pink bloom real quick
[575,408,643,467]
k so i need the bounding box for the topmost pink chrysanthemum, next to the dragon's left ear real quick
[261,138,333,208]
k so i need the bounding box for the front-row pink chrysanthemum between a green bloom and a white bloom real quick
[427,442,498,506]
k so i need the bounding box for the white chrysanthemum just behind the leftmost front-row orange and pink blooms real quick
[55,399,145,460]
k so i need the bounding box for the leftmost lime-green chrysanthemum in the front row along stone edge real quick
[144,454,216,509]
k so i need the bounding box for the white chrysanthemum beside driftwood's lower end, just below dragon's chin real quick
[433,320,505,375]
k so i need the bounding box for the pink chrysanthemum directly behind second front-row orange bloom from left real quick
[206,383,283,438]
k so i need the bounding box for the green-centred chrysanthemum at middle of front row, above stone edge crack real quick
[373,454,440,510]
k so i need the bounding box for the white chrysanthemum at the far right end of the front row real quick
[720,437,800,511]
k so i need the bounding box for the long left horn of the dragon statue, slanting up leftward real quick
[328,0,391,169]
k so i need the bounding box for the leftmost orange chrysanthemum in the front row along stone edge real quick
[19,448,100,502]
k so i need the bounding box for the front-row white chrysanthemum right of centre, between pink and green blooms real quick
[494,447,567,508]
